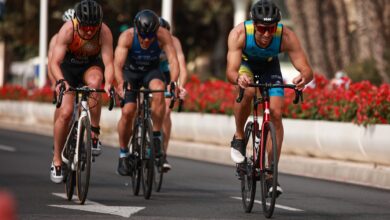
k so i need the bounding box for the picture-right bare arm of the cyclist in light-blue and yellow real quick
[281,27,313,89]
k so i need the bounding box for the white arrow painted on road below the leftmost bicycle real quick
[48,193,145,218]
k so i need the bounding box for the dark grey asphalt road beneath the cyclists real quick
[0,129,390,220]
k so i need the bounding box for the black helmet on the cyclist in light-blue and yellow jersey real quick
[251,0,281,24]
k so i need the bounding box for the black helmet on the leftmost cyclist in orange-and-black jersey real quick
[75,0,103,26]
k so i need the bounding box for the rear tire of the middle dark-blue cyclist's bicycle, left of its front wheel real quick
[130,118,142,196]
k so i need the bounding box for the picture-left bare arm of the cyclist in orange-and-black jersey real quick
[49,21,73,80]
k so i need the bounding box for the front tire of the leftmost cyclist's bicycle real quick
[76,117,92,204]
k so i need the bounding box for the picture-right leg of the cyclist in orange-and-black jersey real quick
[83,65,103,156]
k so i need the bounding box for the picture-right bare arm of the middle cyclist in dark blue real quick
[157,28,179,82]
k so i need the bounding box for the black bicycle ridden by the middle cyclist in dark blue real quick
[121,82,175,199]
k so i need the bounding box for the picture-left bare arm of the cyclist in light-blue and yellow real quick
[226,24,245,84]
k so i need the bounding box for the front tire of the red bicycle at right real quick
[260,122,278,218]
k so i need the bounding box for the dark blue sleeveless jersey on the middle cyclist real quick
[125,29,161,73]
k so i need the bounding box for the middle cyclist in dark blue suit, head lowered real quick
[114,9,179,175]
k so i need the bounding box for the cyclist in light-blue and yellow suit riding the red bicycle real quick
[226,0,313,195]
